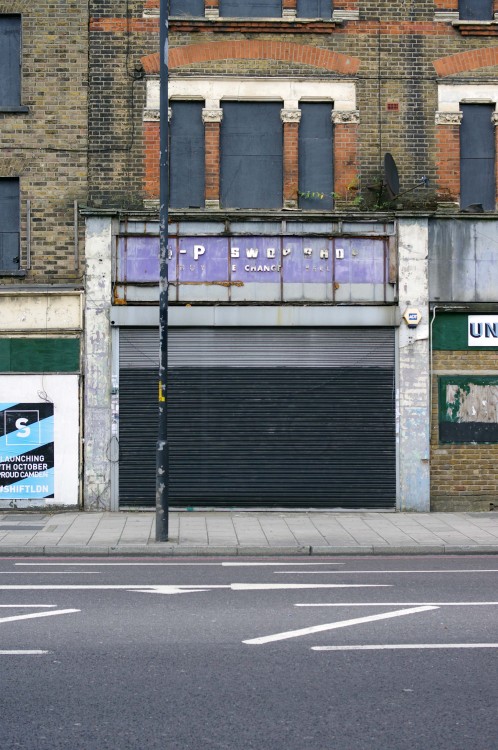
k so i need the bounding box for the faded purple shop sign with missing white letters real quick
[117,236,387,284]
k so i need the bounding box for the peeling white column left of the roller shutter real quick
[83,218,112,510]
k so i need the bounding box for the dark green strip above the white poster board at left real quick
[0,338,80,372]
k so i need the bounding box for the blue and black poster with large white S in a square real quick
[0,401,54,506]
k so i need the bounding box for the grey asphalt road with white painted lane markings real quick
[0,557,498,750]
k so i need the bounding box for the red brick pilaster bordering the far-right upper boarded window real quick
[436,112,462,203]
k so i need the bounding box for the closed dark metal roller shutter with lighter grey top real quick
[119,328,396,508]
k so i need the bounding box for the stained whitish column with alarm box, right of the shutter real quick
[398,218,430,511]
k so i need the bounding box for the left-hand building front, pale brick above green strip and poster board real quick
[0,0,88,508]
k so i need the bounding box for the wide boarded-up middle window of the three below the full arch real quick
[220,102,283,208]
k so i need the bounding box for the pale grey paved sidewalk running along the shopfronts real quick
[0,510,498,556]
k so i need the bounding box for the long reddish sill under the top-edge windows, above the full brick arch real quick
[169,18,342,34]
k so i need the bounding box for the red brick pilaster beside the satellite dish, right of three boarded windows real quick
[332,111,360,202]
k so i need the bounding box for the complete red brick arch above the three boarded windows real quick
[141,40,360,75]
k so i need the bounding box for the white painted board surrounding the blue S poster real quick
[0,374,80,508]
